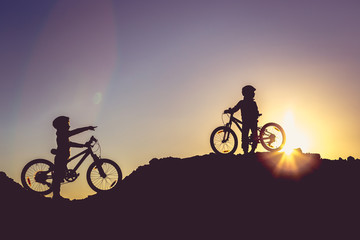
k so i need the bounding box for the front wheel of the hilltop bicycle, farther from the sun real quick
[210,126,238,155]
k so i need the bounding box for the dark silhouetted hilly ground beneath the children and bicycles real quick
[0,153,360,239]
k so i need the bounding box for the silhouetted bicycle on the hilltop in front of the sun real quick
[210,113,286,155]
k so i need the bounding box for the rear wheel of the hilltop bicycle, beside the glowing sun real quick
[259,123,286,152]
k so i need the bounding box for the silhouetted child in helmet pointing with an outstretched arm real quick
[53,116,96,199]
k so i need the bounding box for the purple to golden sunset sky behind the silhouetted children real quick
[0,0,360,199]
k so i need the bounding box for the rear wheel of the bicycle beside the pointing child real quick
[21,159,54,195]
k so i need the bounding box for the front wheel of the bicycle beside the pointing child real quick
[86,159,122,192]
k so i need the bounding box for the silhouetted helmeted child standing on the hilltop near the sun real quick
[224,85,260,154]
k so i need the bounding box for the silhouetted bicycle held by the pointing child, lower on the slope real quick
[21,136,122,195]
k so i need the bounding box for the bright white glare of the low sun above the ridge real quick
[281,111,310,155]
